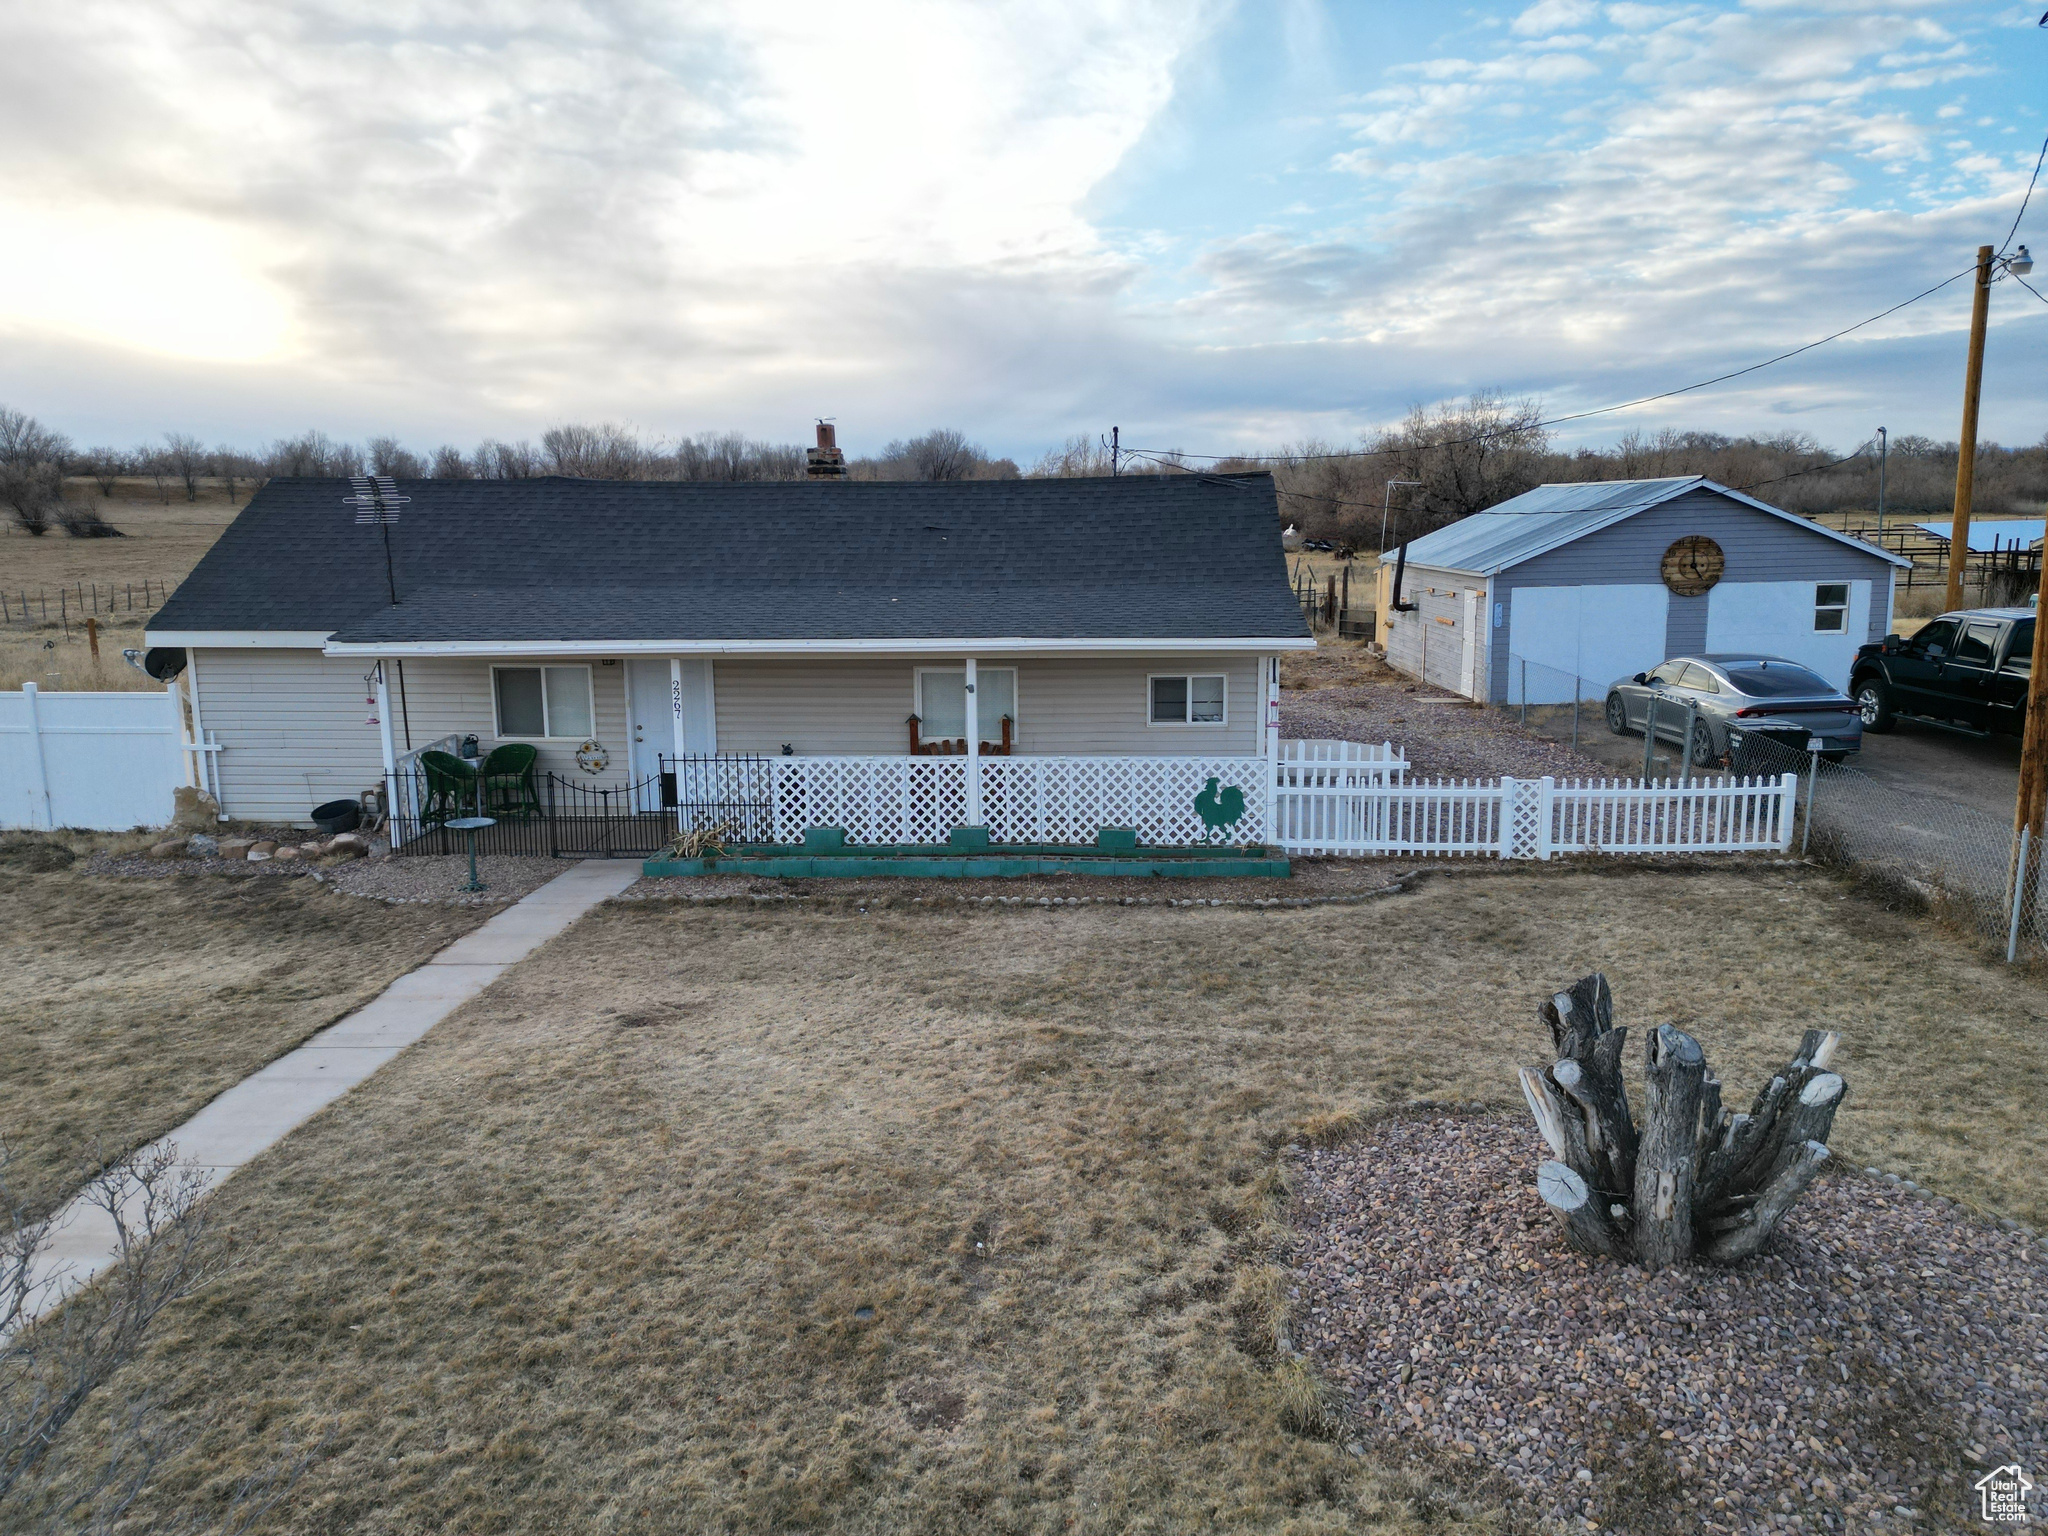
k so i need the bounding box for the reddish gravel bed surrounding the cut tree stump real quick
[1288,1112,2048,1536]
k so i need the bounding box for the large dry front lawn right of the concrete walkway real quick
[28,866,2048,1534]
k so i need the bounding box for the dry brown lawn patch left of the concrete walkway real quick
[0,860,489,1204]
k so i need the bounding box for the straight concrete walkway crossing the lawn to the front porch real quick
[35,858,641,1313]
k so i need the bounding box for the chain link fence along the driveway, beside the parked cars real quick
[1493,655,2048,961]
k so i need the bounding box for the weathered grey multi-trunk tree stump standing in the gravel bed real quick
[1522,973,1847,1270]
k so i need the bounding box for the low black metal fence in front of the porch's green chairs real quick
[391,756,774,858]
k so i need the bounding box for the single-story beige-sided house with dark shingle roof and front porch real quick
[147,475,1313,842]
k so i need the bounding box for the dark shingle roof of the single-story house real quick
[150,475,1307,643]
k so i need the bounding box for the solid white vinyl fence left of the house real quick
[0,682,186,831]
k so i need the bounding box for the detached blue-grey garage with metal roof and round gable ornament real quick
[1378,475,1911,705]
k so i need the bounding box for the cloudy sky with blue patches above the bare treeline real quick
[0,0,2048,461]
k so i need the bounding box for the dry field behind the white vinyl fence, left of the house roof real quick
[0,479,250,692]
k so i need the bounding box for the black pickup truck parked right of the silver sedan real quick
[1849,608,2034,735]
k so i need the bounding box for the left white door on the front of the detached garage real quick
[1503,582,1671,705]
